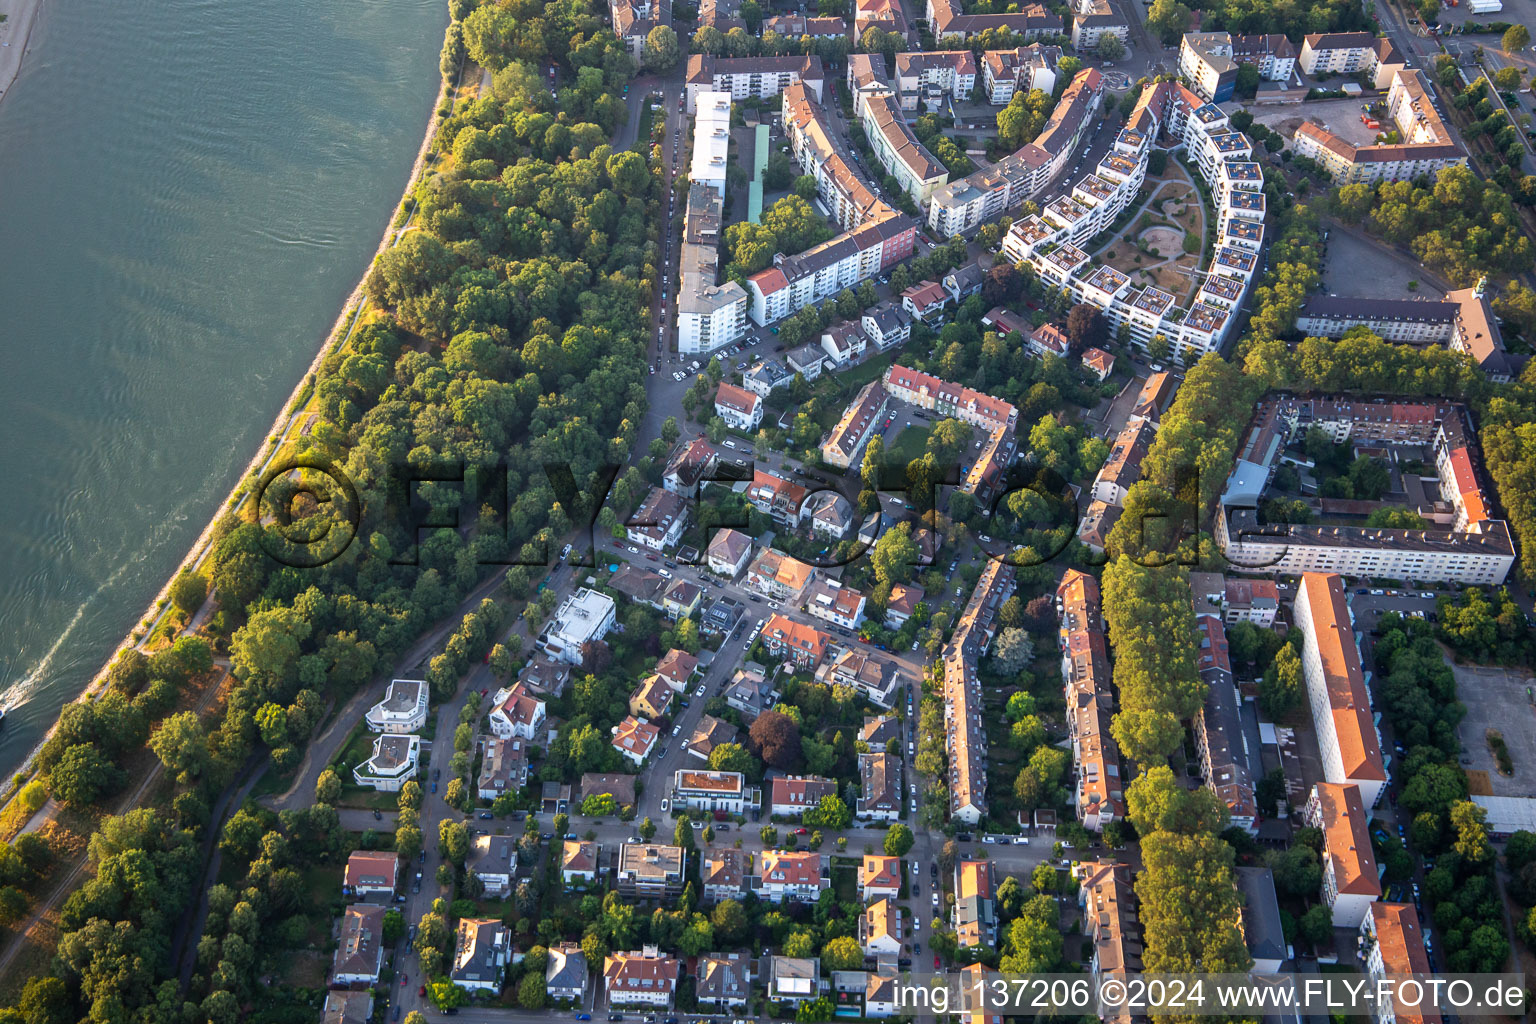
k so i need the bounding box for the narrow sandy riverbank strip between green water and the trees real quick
[0,8,466,838]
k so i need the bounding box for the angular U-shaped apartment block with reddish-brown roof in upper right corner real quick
[1292,68,1467,184]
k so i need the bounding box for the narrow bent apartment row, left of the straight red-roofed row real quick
[943,559,1014,824]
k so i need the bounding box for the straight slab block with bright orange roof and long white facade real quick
[1292,573,1387,808]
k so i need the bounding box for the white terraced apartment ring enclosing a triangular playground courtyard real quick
[1003,81,1266,365]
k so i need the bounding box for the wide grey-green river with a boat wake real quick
[0,0,447,778]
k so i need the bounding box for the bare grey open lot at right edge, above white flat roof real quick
[1452,665,1536,797]
